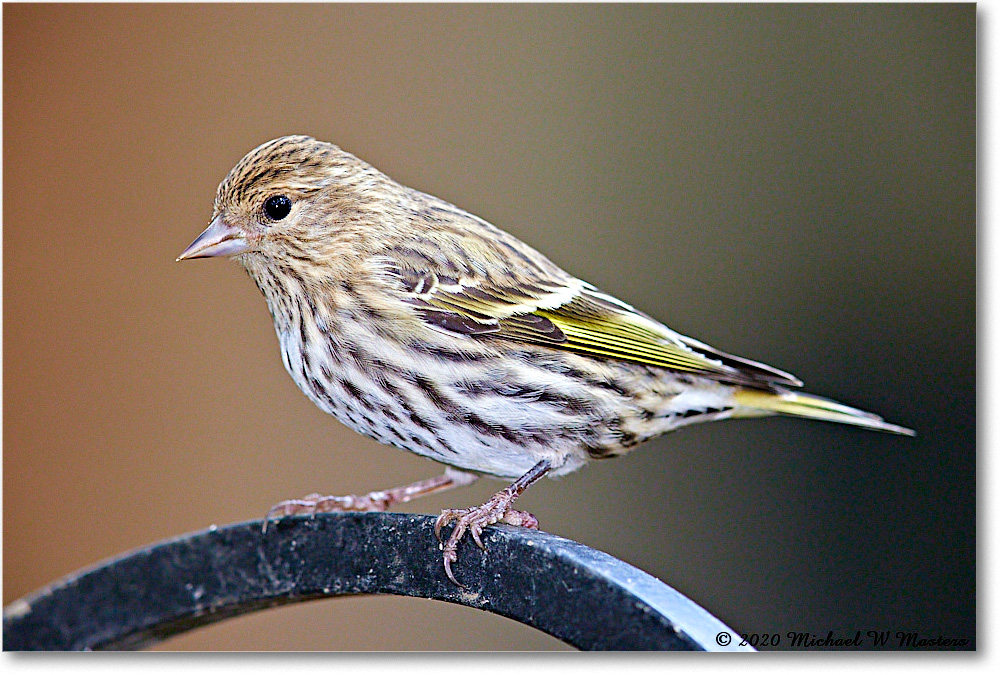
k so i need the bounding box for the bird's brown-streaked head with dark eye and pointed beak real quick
[177,136,388,269]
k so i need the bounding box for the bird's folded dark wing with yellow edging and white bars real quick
[392,270,801,387]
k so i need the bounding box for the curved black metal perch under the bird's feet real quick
[3,513,750,650]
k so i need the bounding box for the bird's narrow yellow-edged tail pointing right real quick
[733,389,916,436]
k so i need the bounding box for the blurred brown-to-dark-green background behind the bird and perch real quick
[3,4,976,650]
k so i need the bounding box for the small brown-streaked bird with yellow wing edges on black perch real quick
[178,136,913,583]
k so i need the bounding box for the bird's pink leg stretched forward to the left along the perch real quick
[263,468,478,534]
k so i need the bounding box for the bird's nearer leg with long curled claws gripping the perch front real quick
[434,459,552,586]
